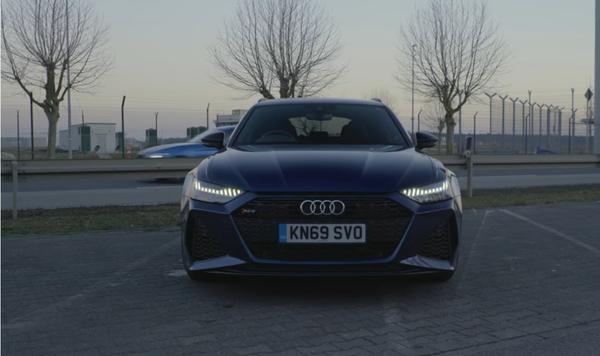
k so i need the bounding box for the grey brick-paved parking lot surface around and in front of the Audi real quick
[1,202,600,355]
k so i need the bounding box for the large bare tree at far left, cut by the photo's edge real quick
[2,0,110,158]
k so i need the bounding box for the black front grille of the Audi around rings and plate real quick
[233,196,412,261]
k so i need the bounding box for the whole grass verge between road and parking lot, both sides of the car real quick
[2,184,600,236]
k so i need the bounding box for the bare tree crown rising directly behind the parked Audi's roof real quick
[211,0,343,99]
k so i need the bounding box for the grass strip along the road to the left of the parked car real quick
[2,204,179,236]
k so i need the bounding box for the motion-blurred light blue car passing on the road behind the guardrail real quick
[138,126,235,158]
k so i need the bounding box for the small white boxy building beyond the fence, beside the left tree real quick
[58,122,117,153]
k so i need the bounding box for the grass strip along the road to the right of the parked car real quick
[463,184,600,209]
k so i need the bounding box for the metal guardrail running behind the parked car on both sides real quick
[2,155,600,175]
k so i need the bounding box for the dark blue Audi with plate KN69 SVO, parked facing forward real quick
[181,99,462,280]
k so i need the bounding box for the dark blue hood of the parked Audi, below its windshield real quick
[195,148,444,193]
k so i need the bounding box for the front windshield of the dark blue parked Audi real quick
[234,104,407,147]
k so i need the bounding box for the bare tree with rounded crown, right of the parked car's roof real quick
[399,0,507,153]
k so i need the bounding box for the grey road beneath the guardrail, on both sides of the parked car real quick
[2,165,600,209]
